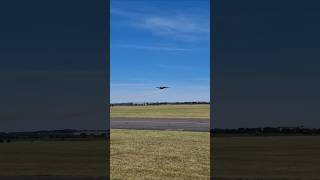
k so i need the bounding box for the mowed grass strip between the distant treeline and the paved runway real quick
[111,104,210,119]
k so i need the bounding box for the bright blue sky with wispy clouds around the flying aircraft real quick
[110,0,210,103]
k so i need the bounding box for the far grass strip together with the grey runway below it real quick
[111,104,210,132]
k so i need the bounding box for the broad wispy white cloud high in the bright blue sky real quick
[110,8,210,42]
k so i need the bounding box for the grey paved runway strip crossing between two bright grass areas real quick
[110,118,210,132]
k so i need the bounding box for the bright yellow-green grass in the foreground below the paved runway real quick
[111,130,210,180]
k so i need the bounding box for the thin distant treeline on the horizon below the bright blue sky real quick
[111,101,210,106]
